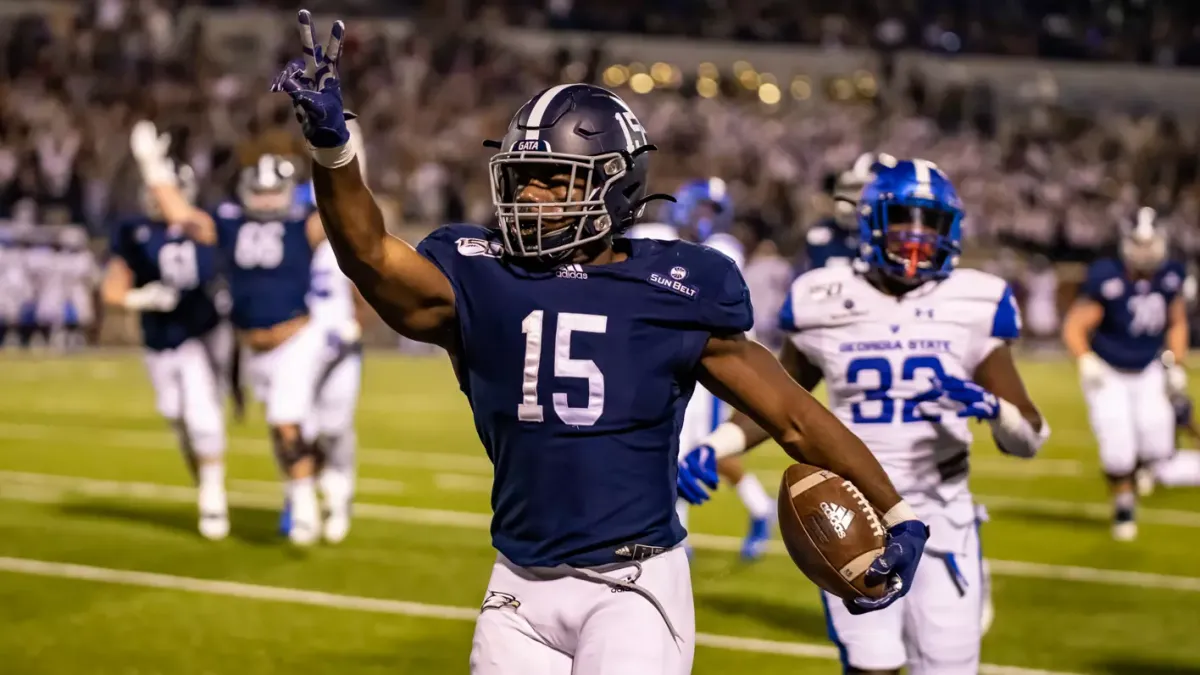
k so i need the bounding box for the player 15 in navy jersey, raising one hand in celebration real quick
[272,11,928,675]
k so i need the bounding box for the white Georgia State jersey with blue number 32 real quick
[780,267,1020,498]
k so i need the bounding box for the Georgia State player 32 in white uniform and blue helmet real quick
[680,160,1050,675]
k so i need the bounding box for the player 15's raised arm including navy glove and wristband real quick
[272,10,455,346]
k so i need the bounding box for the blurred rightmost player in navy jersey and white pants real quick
[1062,207,1188,540]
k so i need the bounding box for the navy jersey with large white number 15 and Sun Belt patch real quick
[418,226,754,567]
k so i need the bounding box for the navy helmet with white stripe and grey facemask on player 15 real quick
[485,84,664,259]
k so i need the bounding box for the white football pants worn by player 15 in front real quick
[470,546,696,675]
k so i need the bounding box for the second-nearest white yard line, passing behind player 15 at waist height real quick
[0,471,1200,593]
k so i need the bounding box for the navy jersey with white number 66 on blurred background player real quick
[212,202,312,329]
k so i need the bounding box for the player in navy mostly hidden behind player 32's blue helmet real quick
[804,153,896,269]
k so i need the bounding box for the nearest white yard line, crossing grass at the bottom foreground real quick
[0,557,1070,675]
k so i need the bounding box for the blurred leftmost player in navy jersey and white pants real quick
[101,156,229,539]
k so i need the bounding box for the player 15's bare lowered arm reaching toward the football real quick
[700,335,901,513]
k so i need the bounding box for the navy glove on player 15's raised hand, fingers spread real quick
[271,10,355,148]
